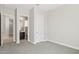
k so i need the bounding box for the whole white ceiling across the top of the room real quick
[0,4,62,12]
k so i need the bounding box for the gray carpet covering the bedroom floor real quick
[0,41,79,54]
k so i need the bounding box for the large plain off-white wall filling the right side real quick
[47,5,79,49]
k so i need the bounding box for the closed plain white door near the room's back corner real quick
[35,14,44,42]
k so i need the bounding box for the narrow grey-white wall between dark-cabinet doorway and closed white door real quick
[29,8,34,42]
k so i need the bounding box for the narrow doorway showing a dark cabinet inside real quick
[20,16,28,42]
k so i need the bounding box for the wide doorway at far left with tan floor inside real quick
[2,15,13,45]
